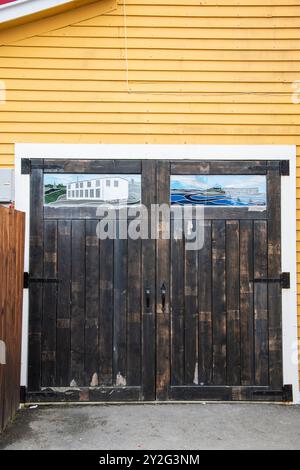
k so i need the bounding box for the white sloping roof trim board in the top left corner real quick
[0,0,74,24]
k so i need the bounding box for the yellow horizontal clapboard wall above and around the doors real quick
[0,0,300,374]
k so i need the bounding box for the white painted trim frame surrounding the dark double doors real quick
[15,144,300,403]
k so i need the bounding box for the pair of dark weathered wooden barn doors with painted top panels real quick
[28,159,283,401]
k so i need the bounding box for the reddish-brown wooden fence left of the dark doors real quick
[0,206,25,432]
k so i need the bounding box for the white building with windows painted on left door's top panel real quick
[67,176,129,201]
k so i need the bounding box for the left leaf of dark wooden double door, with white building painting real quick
[28,160,155,401]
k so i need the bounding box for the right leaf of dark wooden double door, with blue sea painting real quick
[157,161,283,400]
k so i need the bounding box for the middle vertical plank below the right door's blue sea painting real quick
[212,220,227,385]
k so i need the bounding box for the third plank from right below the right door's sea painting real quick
[226,220,241,385]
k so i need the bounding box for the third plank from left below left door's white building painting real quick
[71,220,85,386]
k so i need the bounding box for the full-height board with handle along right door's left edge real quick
[156,160,170,400]
